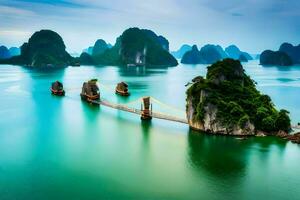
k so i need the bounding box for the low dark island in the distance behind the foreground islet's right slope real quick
[260,50,293,66]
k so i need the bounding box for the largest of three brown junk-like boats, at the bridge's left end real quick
[80,79,100,103]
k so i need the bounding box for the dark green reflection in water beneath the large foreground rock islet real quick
[188,130,287,180]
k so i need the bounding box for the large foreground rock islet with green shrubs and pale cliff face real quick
[186,59,290,135]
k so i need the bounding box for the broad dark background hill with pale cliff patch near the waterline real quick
[93,28,178,66]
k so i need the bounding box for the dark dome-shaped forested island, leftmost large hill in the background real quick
[2,30,73,67]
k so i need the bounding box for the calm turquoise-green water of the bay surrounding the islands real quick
[0,61,300,200]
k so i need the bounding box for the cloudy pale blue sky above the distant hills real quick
[0,0,300,53]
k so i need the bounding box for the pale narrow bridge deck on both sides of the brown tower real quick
[92,100,188,124]
